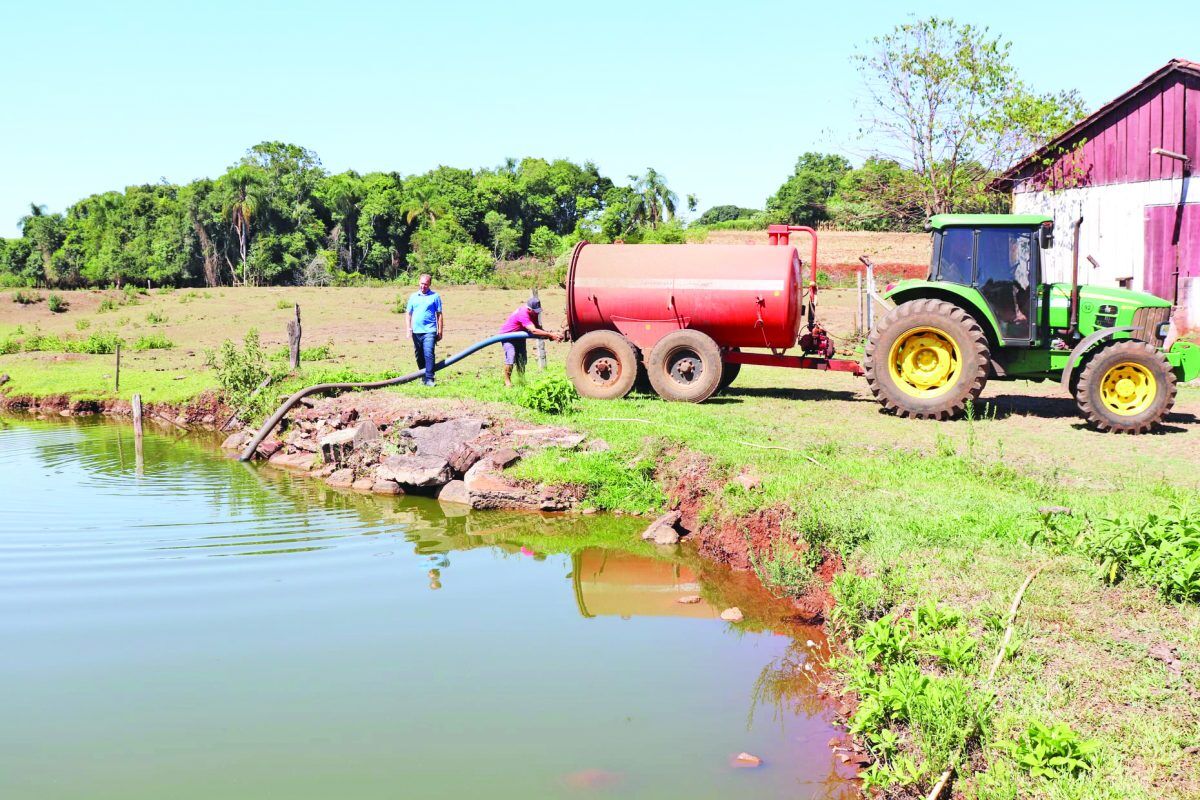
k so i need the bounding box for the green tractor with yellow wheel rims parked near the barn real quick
[863,213,1200,433]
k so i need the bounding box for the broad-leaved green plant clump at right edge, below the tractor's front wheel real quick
[1082,505,1200,602]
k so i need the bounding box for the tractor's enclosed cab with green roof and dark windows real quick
[928,213,1054,347]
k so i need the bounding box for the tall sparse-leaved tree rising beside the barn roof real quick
[856,17,1084,216]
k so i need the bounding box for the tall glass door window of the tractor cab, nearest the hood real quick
[976,228,1034,339]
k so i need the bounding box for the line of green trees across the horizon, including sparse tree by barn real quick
[0,17,1082,287]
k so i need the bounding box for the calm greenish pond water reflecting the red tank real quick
[0,417,848,800]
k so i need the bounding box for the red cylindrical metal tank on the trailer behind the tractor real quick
[566,243,802,351]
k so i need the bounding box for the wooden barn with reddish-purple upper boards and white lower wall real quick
[997,59,1200,333]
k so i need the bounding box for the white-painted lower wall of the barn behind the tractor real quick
[1013,179,1198,289]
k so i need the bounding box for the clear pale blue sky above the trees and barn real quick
[0,0,1200,236]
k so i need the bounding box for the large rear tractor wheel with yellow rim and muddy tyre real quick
[863,300,991,420]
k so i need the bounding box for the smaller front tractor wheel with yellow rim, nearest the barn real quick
[1075,339,1176,433]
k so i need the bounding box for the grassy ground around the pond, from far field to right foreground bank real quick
[0,281,1200,799]
